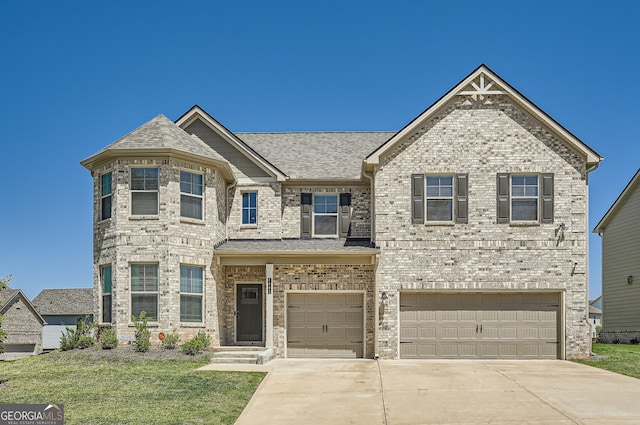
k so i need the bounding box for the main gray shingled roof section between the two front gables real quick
[235,132,395,180]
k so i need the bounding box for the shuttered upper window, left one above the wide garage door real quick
[411,174,469,224]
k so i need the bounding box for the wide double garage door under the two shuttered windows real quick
[400,293,560,359]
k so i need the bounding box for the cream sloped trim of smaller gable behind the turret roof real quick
[175,105,287,181]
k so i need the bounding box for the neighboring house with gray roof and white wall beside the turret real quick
[33,288,93,350]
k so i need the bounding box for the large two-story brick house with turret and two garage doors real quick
[82,65,602,359]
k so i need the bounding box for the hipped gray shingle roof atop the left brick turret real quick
[81,114,233,180]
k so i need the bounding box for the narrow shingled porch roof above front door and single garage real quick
[215,238,379,254]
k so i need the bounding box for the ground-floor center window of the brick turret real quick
[131,264,158,320]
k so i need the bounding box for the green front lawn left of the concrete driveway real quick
[0,350,265,425]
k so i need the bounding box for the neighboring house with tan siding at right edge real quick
[593,170,640,343]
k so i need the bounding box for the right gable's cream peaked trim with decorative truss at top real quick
[364,64,603,168]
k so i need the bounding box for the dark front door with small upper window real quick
[236,284,262,342]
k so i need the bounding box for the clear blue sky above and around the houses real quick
[0,0,640,298]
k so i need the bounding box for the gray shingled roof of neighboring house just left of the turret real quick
[32,288,93,316]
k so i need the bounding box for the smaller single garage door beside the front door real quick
[287,293,364,358]
